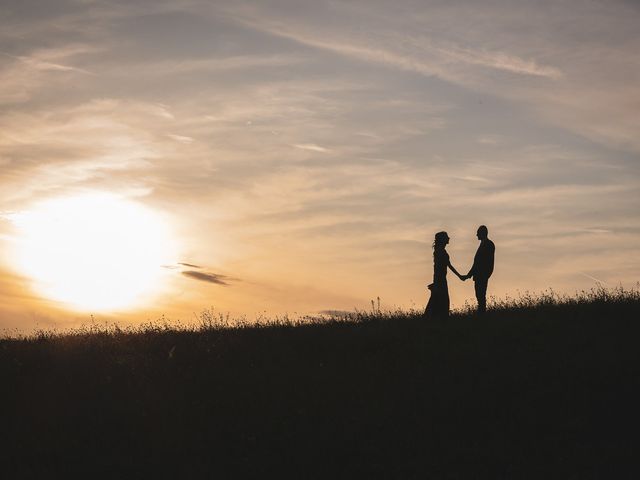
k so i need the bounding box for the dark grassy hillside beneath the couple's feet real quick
[0,291,640,479]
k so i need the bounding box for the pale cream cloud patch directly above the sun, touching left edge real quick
[0,99,173,202]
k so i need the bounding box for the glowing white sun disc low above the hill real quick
[14,193,176,312]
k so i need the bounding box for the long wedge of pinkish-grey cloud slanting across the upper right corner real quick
[221,1,640,152]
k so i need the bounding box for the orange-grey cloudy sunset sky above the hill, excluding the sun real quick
[0,0,640,330]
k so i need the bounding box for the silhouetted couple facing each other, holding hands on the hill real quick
[424,225,496,319]
